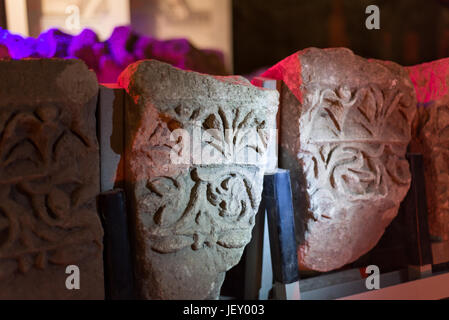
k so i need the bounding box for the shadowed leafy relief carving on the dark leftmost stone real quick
[0,105,101,278]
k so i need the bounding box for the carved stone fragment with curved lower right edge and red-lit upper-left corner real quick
[262,48,415,271]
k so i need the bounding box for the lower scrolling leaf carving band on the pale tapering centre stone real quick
[148,167,261,253]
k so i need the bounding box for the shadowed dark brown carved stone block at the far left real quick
[0,59,104,299]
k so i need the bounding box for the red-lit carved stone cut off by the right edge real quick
[408,59,449,241]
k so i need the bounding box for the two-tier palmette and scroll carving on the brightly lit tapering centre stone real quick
[133,104,269,253]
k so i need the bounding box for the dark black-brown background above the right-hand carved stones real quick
[233,0,449,74]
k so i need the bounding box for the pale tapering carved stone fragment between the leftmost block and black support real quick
[119,60,279,299]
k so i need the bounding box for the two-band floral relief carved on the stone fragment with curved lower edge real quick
[298,85,410,218]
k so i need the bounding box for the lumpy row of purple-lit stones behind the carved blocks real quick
[0,26,226,82]
